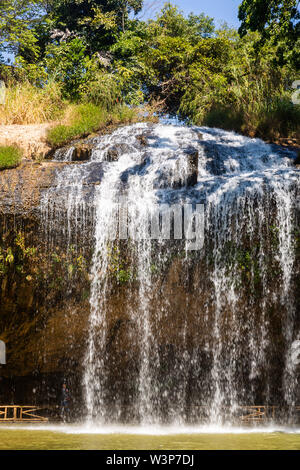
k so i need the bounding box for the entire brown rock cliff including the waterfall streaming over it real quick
[0,124,300,421]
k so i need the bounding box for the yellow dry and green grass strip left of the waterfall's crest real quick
[0,77,141,147]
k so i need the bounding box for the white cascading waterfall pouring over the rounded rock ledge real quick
[41,122,300,423]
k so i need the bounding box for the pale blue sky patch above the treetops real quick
[143,0,242,28]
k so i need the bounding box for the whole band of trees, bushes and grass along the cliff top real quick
[0,0,300,145]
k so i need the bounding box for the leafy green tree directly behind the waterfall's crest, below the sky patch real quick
[112,3,219,111]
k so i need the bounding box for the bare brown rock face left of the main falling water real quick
[0,162,89,403]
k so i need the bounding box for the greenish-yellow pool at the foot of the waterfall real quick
[0,425,300,450]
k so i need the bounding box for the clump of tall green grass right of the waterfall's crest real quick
[202,76,300,140]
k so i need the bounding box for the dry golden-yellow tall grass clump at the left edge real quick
[0,81,66,124]
